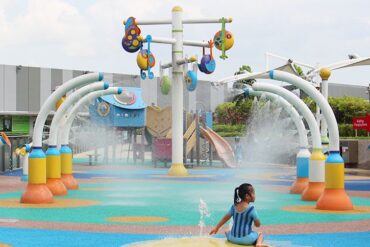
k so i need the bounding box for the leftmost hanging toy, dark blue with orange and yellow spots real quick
[122,17,142,53]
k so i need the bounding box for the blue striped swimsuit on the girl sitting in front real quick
[227,204,258,245]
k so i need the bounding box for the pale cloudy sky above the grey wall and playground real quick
[0,0,370,86]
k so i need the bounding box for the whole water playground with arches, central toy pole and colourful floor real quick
[0,6,370,247]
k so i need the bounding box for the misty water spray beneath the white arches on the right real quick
[242,96,299,164]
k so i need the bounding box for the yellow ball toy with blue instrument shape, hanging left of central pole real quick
[136,35,155,80]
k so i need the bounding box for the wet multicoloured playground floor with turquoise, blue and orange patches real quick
[0,160,370,247]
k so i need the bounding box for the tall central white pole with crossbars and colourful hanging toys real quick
[122,6,234,176]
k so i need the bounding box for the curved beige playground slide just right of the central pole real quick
[200,127,235,168]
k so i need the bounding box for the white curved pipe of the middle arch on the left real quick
[48,82,109,146]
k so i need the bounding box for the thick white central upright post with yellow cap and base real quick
[168,6,188,176]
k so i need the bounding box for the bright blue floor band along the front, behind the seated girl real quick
[0,228,370,247]
